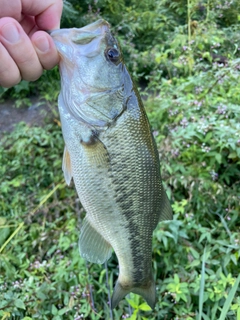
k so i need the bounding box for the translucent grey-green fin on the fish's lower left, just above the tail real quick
[79,218,112,264]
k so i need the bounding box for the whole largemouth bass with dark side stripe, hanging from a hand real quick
[51,20,172,308]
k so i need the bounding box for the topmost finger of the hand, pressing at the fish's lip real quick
[22,0,63,30]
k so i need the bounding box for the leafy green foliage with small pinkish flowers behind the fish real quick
[0,0,240,320]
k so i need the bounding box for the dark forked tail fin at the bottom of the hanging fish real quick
[111,281,156,309]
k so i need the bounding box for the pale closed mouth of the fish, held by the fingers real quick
[48,19,110,52]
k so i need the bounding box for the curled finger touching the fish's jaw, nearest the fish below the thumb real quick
[31,31,59,70]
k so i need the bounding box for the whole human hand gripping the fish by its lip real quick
[0,0,63,88]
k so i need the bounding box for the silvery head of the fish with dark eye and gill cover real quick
[50,19,127,126]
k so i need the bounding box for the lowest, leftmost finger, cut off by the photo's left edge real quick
[0,43,21,88]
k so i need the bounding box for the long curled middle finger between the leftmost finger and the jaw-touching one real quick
[0,18,42,81]
